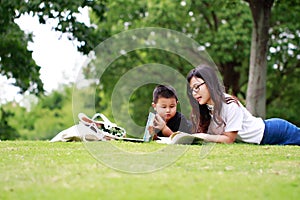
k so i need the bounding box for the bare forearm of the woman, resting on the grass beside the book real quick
[196,131,237,144]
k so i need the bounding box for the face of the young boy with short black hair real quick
[152,97,177,122]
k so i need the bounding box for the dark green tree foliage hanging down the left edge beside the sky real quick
[0,0,44,94]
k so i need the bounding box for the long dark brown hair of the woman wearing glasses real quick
[186,65,226,133]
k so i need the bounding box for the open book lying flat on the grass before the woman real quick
[156,131,204,144]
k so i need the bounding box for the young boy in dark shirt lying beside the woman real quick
[152,85,192,139]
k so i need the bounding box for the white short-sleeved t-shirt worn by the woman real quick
[208,94,265,144]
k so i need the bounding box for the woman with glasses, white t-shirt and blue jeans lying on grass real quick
[187,66,300,145]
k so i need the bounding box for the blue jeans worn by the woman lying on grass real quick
[260,118,300,145]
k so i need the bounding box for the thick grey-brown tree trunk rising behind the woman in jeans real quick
[246,0,274,118]
